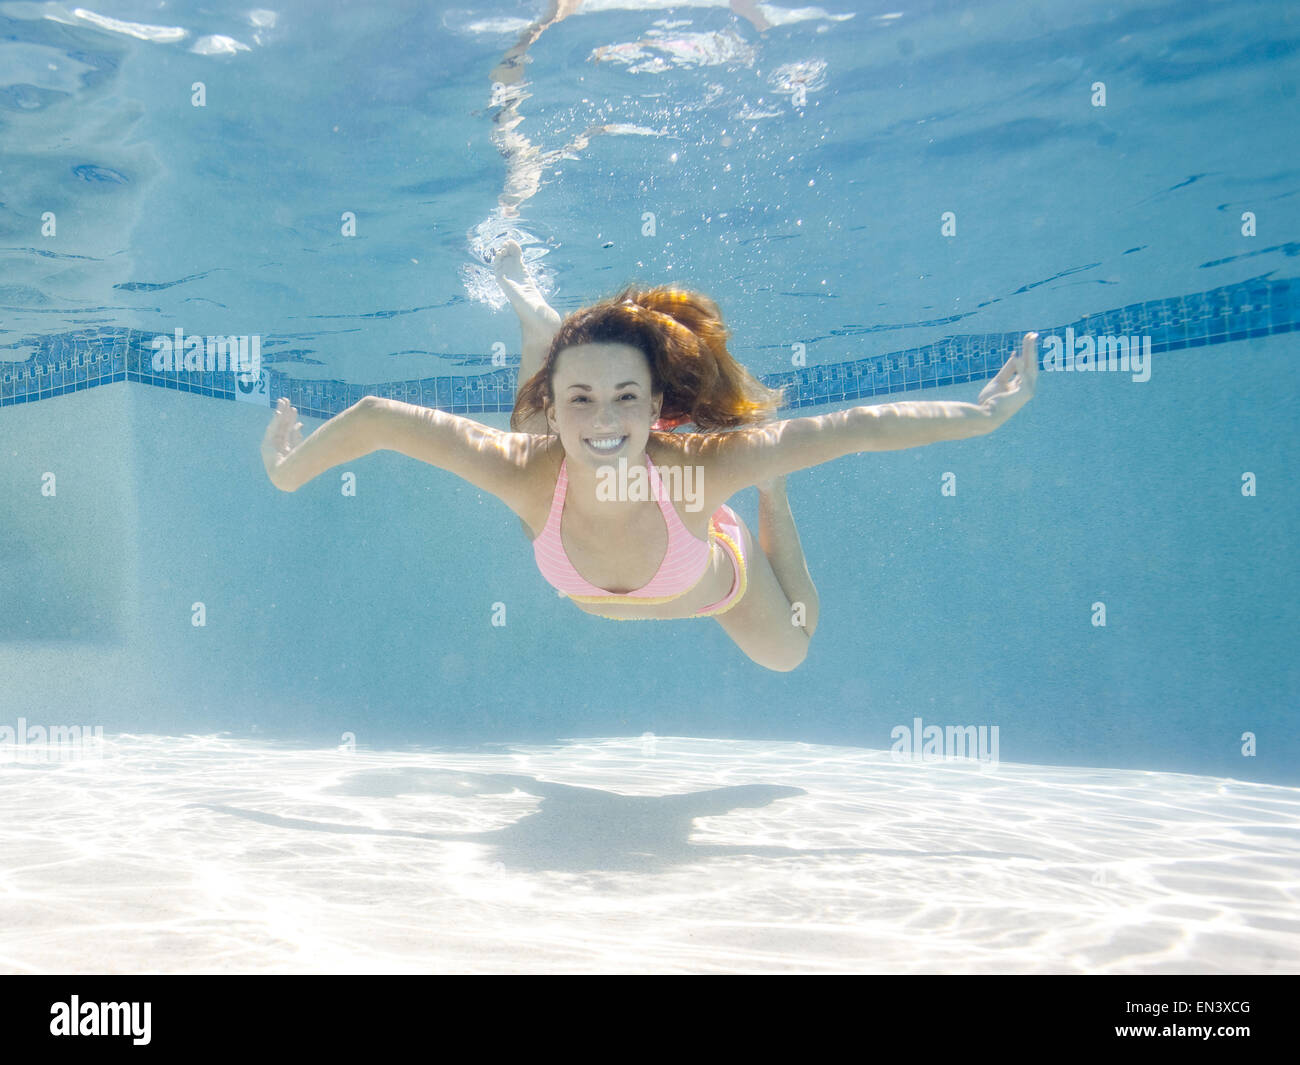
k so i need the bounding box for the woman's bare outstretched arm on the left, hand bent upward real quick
[263,395,533,514]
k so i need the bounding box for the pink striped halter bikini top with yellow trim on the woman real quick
[533,453,712,602]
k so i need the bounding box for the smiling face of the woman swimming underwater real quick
[546,343,663,467]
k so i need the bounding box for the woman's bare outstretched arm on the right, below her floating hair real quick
[710,333,1039,498]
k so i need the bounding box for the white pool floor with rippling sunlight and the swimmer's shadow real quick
[0,736,1300,973]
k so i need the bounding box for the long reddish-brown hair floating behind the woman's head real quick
[510,285,783,433]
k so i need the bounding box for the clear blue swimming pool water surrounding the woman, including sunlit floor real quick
[0,0,1300,971]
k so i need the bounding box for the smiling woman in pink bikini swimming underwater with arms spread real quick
[261,241,1037,672]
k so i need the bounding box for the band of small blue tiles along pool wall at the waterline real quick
[0,278,1300,419]
